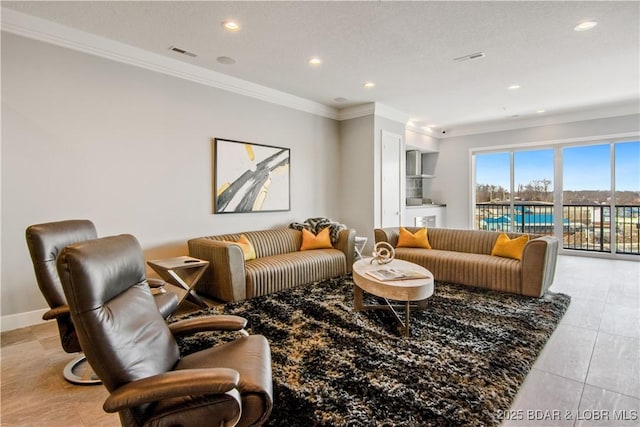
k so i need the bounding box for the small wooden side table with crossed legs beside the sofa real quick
[147,256,209,308]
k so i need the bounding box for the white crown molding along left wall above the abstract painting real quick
[1,7,338,120]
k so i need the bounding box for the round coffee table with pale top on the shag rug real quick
[353,258,433,336]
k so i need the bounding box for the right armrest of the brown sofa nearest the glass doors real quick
[521,236,558,297]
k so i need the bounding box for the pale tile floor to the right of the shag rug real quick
[503,256,640,426]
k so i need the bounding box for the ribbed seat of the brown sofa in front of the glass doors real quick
[396,248,522,293]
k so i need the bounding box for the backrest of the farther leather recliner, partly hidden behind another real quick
[26,219,98,308]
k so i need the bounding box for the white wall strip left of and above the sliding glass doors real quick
[432,114,640,228]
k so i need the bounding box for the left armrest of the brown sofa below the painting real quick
[188,237,247,301]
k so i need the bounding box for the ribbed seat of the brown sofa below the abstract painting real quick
[245,249,347,297]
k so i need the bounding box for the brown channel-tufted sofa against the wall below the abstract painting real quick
[188,228,356,301]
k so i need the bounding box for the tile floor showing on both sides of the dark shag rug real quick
[0,256,640,427]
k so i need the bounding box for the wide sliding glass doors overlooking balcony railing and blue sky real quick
[473,141,640,255]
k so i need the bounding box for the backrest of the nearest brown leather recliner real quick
[58,235,179,391]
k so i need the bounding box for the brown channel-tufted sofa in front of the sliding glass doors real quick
[375,227,558,297]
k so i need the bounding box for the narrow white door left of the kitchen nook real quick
[380,131,402,227]
